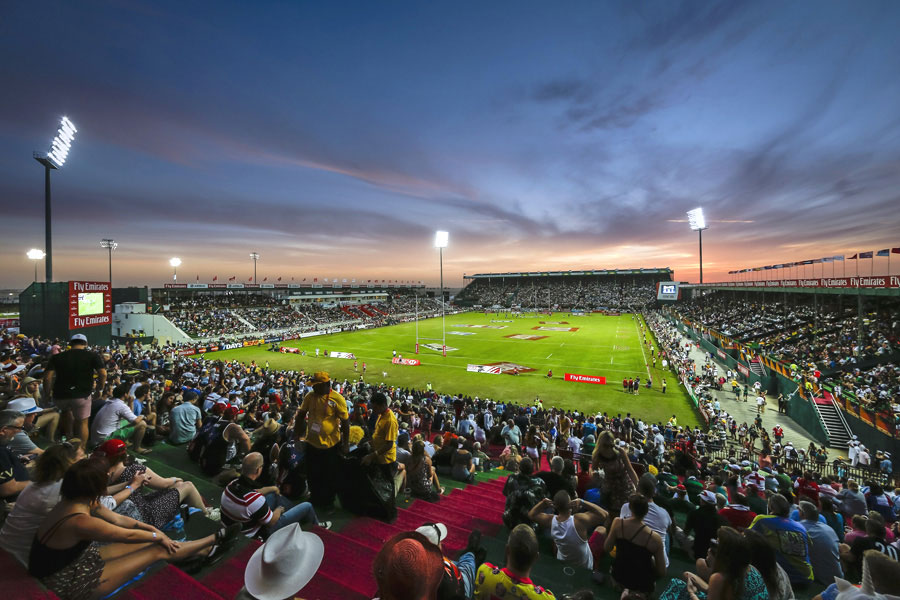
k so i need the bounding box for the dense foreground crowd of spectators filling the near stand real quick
[0,314,900,600]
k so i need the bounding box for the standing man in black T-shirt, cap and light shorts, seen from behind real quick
[44,333,106,448]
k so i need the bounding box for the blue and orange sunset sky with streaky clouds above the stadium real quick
[0,0,900,288]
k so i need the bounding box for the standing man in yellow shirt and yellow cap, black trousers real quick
[297,371,350,507]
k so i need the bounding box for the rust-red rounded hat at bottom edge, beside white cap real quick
[372,531,442,600]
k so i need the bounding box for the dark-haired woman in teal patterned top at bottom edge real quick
[660,527,769,600]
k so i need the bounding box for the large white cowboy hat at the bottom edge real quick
[244,523,325,600]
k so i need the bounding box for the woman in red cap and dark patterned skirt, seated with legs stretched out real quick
[93,439,208,529]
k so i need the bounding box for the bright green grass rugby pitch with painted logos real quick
[200,312,697,425]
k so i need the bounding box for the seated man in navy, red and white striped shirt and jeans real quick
[221,452,331,537]
